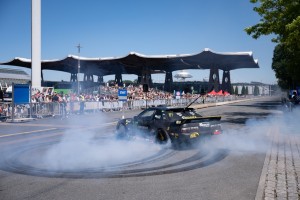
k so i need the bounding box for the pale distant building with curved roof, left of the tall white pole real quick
[0,68,31,89]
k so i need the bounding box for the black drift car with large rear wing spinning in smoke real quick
[116,106,221,144]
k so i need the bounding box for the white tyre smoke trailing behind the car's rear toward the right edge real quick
[203,108,300,154]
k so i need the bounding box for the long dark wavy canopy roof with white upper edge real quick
[0,49,259,76]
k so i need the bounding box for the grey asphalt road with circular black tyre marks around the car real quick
[0,98,281,200]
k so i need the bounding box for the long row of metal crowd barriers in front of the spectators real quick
[0,96,244,121]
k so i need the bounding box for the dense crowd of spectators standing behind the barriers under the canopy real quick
[0,85,209,118]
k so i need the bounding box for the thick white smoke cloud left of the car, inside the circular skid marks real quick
[43,124,164,171]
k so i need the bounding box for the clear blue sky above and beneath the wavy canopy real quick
[0,0,276,84]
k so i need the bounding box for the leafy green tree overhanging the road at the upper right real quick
[245,0,300,88]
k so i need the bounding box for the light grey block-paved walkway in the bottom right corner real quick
[255,133,300,200]
